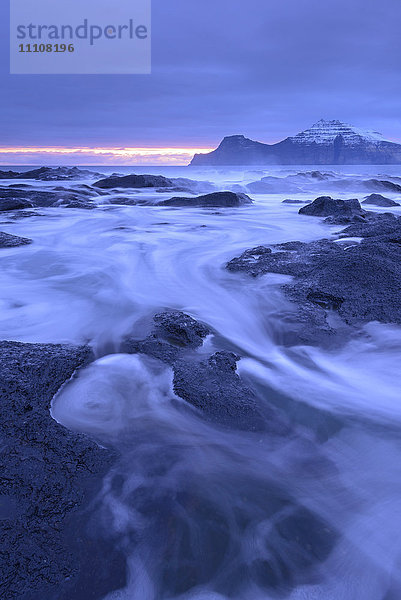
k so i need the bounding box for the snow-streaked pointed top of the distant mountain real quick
[290,119,386,146]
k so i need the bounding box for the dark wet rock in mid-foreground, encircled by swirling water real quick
[121,311,287,433]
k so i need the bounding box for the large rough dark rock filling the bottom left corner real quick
[0,341,119,600]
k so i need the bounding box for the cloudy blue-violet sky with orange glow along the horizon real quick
[0,0,401,164]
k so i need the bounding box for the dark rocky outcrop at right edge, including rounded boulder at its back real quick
[226,197,401,345]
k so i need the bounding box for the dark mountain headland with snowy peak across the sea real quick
[191,119,401,166]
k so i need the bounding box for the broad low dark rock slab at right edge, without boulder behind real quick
[227,234,401,343]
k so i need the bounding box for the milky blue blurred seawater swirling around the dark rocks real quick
[0,167,401,600]
